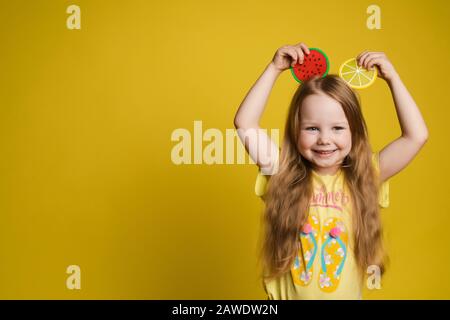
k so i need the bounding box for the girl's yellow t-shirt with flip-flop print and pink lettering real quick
[255,153,389,300]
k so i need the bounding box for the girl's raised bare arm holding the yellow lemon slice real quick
[357,52,428,181]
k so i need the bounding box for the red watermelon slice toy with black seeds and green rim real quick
[291,48,330,83]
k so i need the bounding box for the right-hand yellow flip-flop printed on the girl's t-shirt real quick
[319,218,348,292]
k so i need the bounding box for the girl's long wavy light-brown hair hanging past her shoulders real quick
[260,75,387,280]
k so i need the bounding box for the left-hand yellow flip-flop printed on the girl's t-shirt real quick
[291,214,319,286]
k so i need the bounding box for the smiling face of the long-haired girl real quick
[298,94,352,175]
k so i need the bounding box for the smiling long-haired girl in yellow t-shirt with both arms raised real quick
[234,43,428,299]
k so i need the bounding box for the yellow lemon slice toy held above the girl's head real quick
[339,58,378,89]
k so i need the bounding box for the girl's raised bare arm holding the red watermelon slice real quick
[234,43,309,174]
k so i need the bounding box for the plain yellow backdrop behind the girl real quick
[0,0,450,299]
